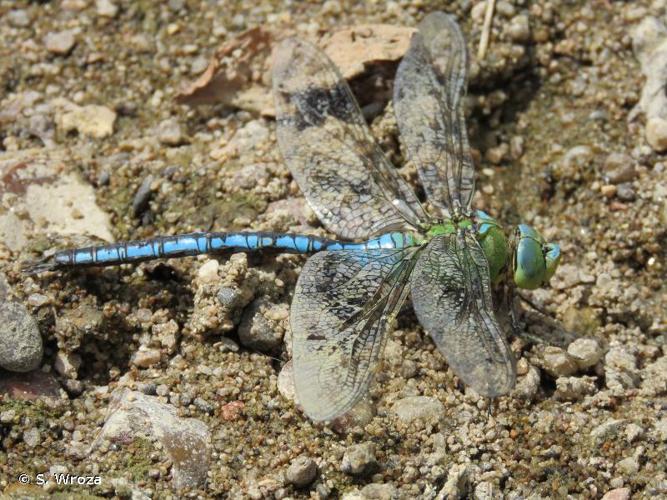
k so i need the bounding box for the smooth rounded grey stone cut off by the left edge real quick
[0,300,44,372]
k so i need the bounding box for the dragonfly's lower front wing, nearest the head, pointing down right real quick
[411,231,516,397]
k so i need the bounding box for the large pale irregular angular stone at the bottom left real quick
[98,388,211,489]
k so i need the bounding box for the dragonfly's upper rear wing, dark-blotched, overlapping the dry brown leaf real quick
[273,38,425,239]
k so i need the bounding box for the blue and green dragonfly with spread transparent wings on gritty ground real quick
[28,12,561,421]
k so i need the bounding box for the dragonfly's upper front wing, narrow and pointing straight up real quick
[394,12,475,215]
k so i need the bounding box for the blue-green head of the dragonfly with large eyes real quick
[513,224,560,290]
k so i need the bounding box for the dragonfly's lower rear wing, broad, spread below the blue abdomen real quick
[290,248,416,420]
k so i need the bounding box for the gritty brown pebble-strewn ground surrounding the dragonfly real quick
[0,0,667,500]
